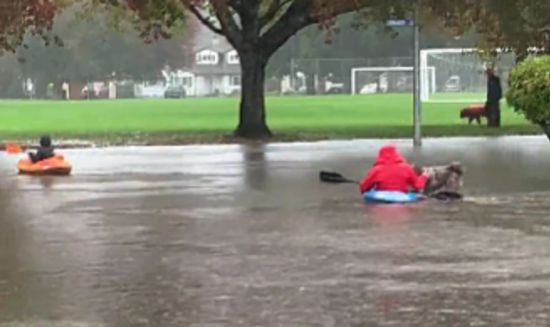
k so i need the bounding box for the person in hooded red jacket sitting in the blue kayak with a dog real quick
[360,145,427,193]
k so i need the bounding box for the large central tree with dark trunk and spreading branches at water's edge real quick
[96,0,422,138]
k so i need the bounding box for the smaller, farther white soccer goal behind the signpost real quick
[351,67,435,98]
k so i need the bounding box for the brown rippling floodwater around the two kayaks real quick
[0,137,550,327]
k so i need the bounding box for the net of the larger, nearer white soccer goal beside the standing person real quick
[420,49,515,103]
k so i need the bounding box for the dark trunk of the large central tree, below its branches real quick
[234,52,272,139]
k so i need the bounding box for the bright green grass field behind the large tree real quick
[0,94,538,143]
